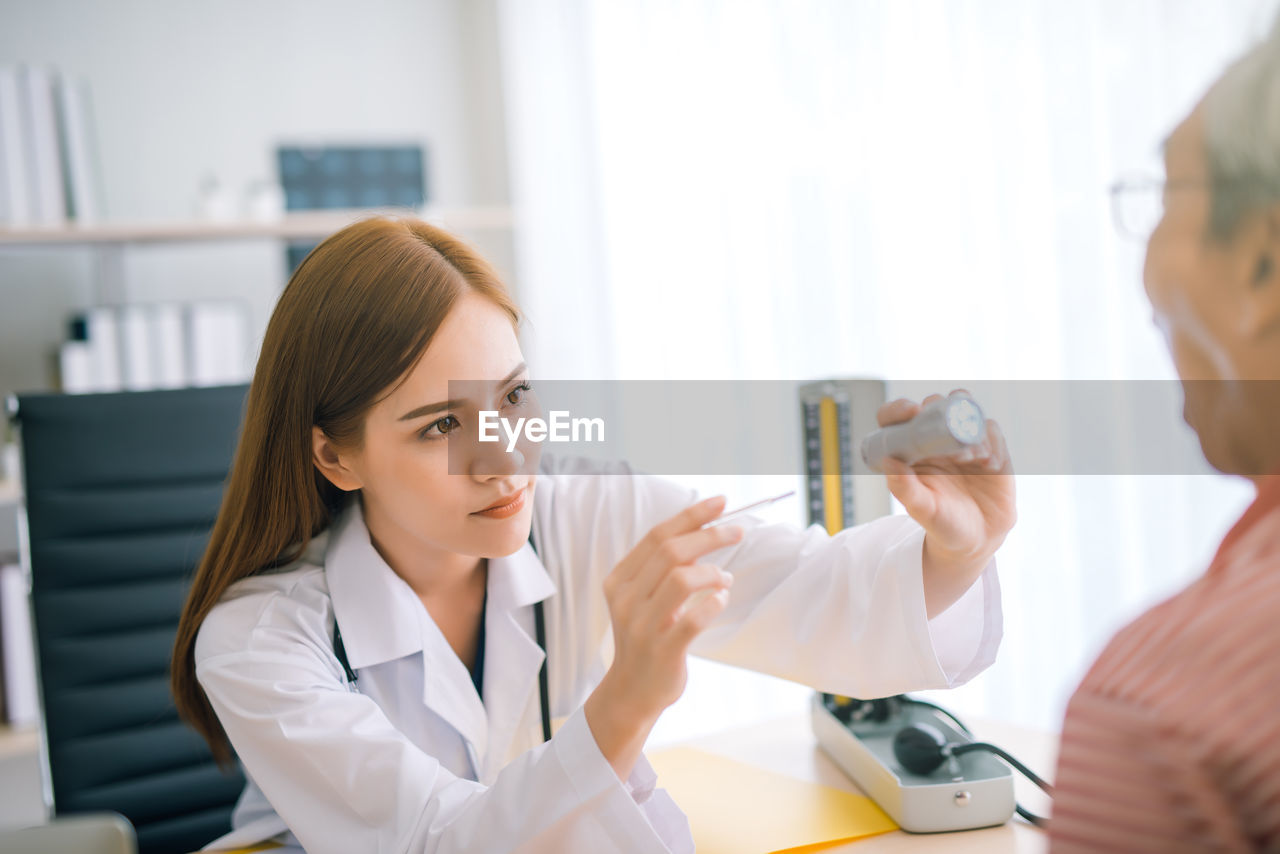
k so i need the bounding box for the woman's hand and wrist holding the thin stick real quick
[584,495,742,780]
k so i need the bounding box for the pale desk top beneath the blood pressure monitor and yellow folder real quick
[675,714,1057,854]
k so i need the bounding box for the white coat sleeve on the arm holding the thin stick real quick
[196,588,692,854]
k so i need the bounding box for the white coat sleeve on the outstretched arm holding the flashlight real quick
[547,462,1002,698]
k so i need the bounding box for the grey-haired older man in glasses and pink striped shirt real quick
[1051,15,1280,854]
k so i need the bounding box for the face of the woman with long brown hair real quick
[344,293,538,566]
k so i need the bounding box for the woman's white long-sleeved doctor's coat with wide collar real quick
[196,456,1001,854]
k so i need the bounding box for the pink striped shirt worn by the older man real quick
[1050,475,1280,854]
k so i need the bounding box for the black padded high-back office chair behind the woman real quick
[10,385,246,854]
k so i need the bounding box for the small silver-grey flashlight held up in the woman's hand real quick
[861,392,987,471]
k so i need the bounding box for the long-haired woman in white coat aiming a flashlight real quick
[173,219,1015,854]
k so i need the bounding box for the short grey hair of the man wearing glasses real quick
[1203,17,1280,239]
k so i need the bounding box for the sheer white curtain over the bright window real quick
[499,0,1276,739]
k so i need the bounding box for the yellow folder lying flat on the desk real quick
[649,748,897,854]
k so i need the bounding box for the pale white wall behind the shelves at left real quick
[0,0,511,402]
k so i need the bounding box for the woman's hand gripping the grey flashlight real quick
[876,389,1018,618]
